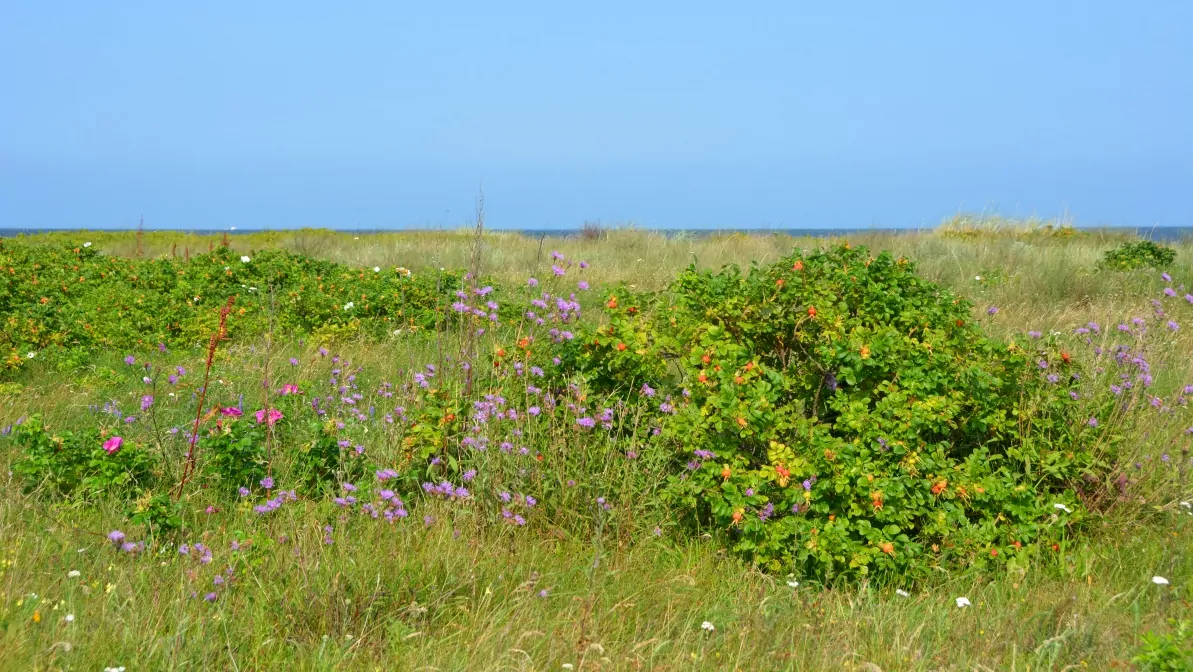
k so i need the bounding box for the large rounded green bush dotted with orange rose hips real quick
[573,246,1113,577]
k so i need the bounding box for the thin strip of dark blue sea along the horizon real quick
[7,226,1193,241]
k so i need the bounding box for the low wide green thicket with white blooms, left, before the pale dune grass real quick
[0,240,462,374]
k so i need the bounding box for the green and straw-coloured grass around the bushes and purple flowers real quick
[0,222,1193,671]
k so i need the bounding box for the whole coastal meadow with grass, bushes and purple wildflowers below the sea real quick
[0,220,1193,671]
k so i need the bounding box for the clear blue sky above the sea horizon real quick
[0,0,1193,228]
